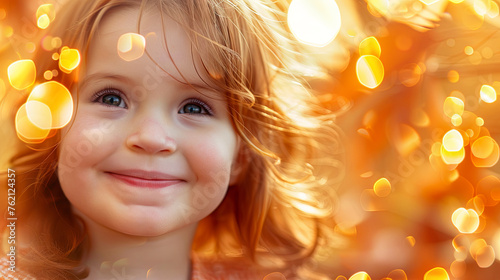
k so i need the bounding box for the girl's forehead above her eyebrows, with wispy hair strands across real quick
[84,7,213,88]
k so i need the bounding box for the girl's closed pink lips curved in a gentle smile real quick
[106,170,185,188]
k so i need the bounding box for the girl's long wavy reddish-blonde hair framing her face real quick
[2,0,343,279]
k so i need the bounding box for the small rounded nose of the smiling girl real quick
[126,118,177,154]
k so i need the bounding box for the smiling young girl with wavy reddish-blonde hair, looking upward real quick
[0,0,341,279]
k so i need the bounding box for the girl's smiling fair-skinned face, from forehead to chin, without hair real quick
[58,8,238,236]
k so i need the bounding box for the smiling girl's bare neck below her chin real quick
[78,211,197,280]
